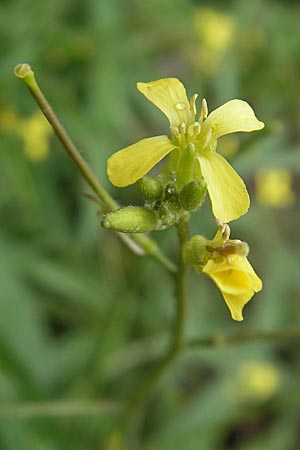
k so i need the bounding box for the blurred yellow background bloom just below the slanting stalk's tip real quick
[16,112,52,161]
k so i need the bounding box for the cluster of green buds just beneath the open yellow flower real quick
[102,171,207,233]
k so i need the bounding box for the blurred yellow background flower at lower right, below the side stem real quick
[235,361,282,401]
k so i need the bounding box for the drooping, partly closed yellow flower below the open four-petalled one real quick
[202,223,262,321]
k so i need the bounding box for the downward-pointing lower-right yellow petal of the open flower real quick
[198,152,250,223]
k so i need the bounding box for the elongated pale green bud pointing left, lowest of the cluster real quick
[101,206,158,233]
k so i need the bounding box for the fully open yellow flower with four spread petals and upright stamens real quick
[107,78,264,222]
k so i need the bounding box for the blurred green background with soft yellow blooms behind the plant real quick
[0,0,300,450]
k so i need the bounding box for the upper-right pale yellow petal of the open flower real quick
[202,100,265,142]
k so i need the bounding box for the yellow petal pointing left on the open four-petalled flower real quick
[107,136,175,187]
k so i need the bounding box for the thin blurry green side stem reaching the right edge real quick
[188,328,300,350]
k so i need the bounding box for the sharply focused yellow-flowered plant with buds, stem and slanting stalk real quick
[15,64,264,448]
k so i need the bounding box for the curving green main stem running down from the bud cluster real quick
[125,218,188,450]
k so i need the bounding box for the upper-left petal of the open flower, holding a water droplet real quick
[137,78,191,126]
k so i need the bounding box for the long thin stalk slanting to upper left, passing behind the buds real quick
[15,64,176,275]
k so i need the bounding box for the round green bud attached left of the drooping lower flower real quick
[182,235,209,272]
